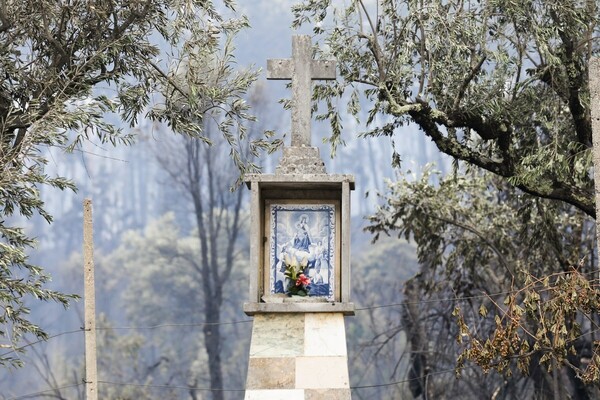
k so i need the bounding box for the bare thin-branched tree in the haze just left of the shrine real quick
[158,130,243,400]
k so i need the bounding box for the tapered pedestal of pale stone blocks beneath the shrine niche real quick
[245,313,351,400]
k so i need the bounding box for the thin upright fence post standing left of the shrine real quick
[83,199,98,400]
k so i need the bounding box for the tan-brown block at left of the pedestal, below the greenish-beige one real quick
[246,357,296,389]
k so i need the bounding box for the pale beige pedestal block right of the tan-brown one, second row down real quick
[296,357,350,389]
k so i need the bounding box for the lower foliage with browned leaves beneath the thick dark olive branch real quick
[367,162,600,388]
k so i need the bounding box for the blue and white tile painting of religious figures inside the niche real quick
[269,204,336,301]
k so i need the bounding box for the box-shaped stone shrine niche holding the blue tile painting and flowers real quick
[245,174,354,313]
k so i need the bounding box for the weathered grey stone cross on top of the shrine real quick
[267,35,335,147]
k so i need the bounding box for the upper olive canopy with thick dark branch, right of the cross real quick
[293,0,600,216]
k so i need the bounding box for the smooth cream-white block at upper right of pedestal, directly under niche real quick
[304,314,347,357]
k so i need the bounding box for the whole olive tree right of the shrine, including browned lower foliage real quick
[294,0,600,398]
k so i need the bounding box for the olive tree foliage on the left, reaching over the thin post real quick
[0,0,274,366]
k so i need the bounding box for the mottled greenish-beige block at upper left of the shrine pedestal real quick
[250,314,304,358]
